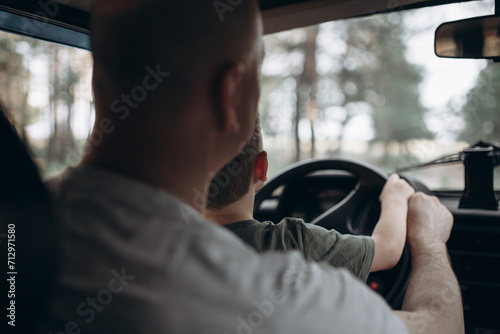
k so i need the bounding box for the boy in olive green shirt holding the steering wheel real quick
[205,120,414,281]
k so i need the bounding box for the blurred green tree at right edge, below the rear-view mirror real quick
[458,62,500,144]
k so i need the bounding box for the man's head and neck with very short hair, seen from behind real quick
[82,0,263,202]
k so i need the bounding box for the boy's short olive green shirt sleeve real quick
[274,218,375,282]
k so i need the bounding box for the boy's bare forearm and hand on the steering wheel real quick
[370,174,415,272]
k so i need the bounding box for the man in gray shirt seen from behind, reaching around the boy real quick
[44,0,463,334]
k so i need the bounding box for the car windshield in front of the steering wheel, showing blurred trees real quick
[260,1,500,190]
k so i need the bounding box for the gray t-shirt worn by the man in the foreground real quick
[45,168,407,334]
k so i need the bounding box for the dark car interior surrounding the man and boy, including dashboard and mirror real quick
[0,0,500,334]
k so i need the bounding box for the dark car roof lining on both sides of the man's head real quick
[0,0,475,49]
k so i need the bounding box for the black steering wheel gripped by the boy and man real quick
[254,159,411,309]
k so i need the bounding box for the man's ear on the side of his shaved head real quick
[216,63,245,133]
